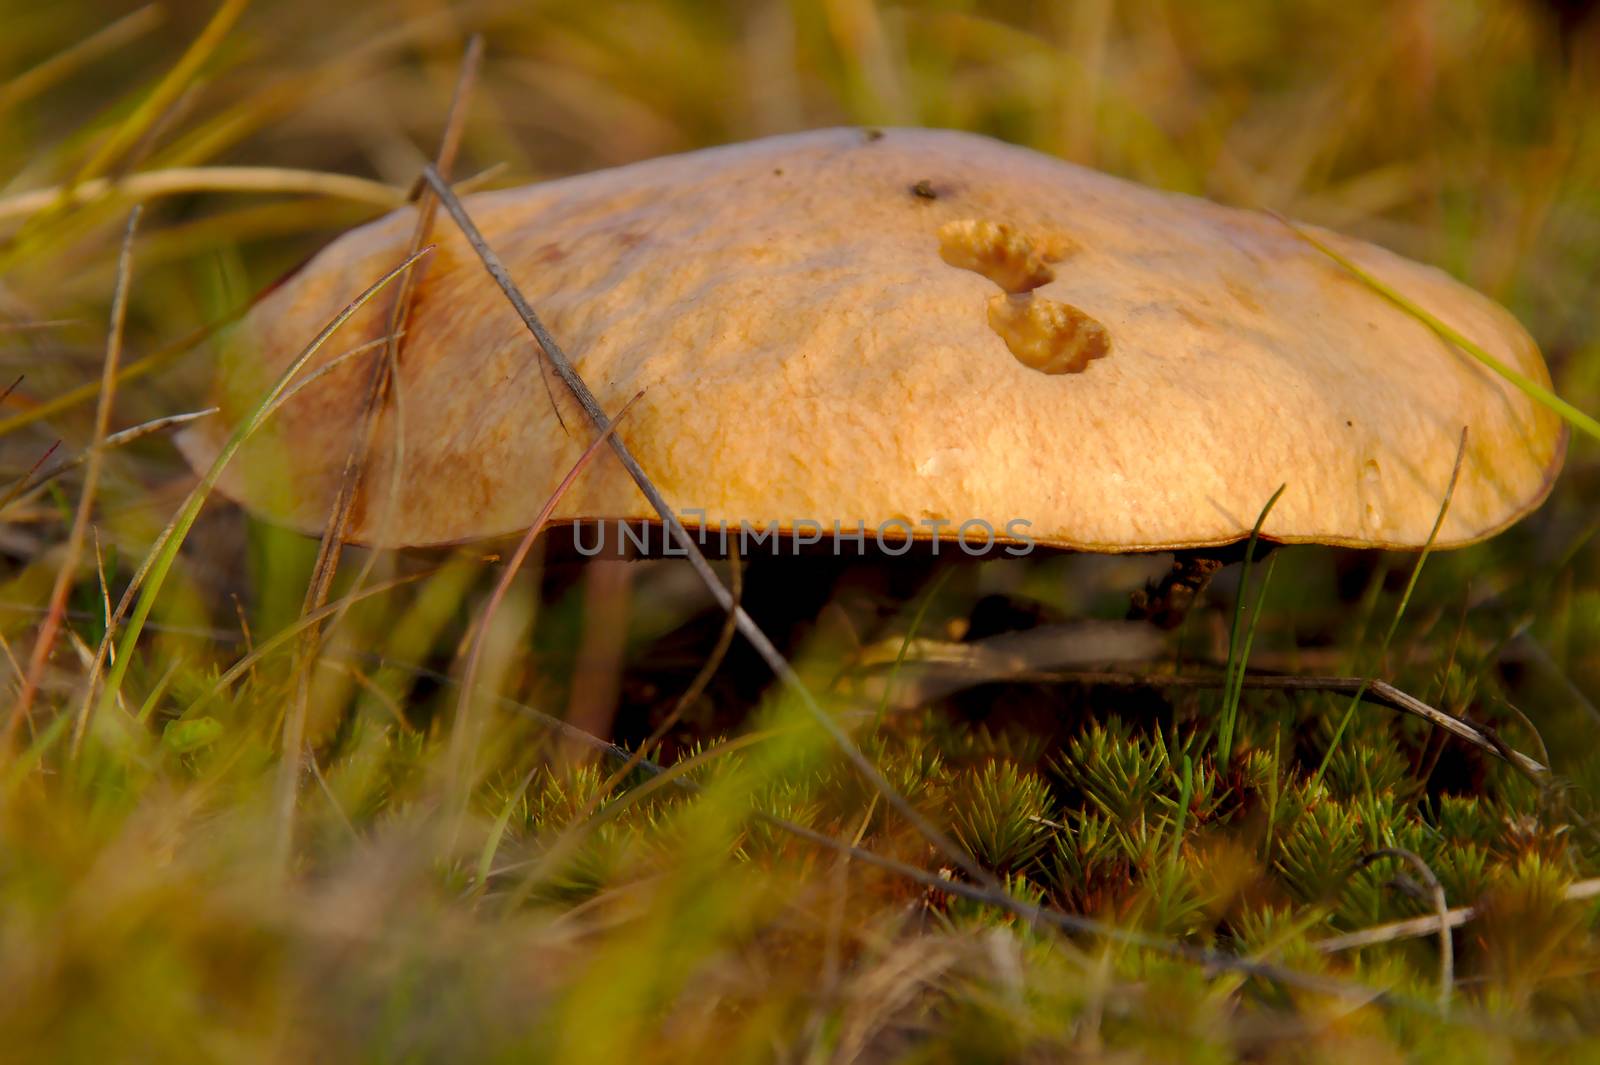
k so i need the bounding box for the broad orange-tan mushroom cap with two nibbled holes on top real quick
[184,130,1565,550]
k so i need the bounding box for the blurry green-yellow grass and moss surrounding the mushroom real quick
[0,0,1600,1062]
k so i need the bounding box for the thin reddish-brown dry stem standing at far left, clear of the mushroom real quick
[6,208,141,745]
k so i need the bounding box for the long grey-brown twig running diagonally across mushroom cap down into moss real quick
[422,166,1003,895]
